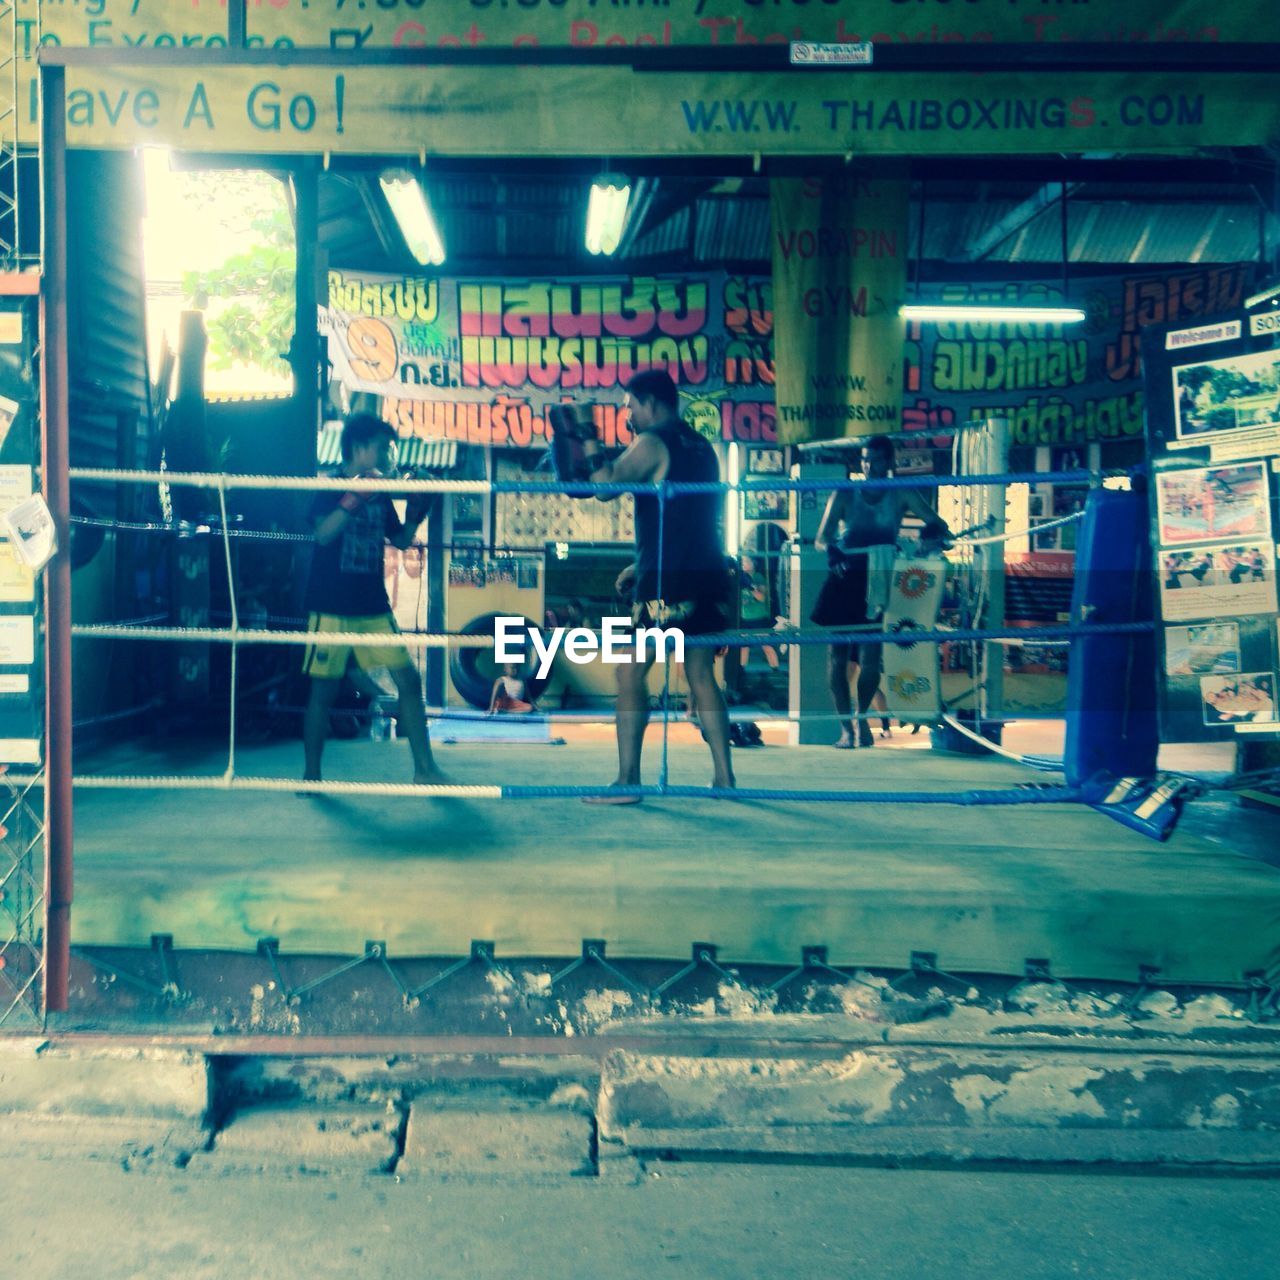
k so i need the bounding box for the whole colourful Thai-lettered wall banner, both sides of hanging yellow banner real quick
[320,262,1256,448]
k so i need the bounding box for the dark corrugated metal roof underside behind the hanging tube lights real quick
[320,161,1258,275]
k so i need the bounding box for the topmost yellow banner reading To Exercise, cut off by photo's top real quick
[24,0,1280,146]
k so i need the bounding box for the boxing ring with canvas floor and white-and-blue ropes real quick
[0,455,1280,1034]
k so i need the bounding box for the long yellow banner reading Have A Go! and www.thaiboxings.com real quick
[57,67,1280,156]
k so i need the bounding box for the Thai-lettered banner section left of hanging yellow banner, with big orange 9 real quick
[320,270,777,448]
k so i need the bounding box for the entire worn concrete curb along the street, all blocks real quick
[0,1021,1280,1176]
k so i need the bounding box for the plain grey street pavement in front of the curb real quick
[0,1152,1280,1280]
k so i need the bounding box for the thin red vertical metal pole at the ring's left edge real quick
[40,67,73,1014]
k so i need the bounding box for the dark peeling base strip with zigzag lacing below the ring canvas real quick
[56,933,1280,1044]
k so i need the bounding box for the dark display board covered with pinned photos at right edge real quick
[1142,311,1280,742]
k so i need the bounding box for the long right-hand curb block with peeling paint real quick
[596,1046,1280,1165]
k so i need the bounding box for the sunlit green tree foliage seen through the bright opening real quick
[182,200,296,374]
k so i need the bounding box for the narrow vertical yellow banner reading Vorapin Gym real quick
[769,175,910,444]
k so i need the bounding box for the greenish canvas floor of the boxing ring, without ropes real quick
[73,726,1280,983]
